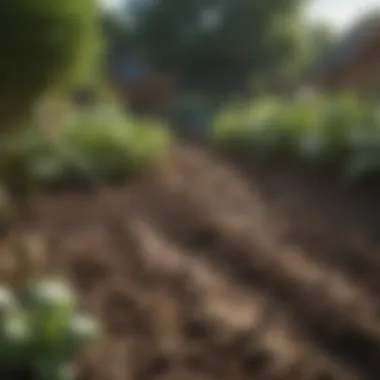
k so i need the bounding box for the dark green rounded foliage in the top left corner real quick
[0,0,97,129]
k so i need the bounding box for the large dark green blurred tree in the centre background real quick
[128,0,301,95]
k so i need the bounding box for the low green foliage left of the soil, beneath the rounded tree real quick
[0,107,170,194]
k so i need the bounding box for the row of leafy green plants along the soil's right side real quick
[212,94,380,181]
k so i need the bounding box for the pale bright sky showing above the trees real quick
[101,0,380,30]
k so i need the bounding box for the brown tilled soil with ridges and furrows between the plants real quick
[0,147,380,380]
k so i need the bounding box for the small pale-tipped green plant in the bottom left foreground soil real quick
[0,279,101,380]
